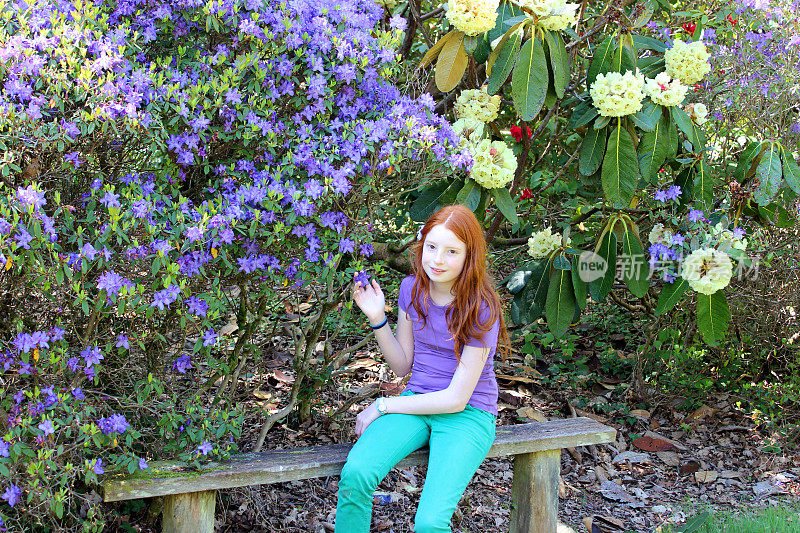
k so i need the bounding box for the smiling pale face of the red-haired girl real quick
[422,224,467,291]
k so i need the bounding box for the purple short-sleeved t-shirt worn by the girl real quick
[398,276,500,416]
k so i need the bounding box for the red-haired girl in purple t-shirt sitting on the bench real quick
[336,205,508,533]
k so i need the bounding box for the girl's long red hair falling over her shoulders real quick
[411,204,509,361]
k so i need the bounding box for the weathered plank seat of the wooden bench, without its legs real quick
[103,418,616,502]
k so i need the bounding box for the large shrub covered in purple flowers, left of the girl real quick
[0,0,463,530]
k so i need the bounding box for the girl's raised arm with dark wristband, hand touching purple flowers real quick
[353,278,414,377]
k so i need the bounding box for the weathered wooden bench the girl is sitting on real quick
[103,418,617,533]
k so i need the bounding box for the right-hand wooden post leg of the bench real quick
[511,450,561,533]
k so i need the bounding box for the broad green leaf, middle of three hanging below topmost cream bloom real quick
[511,37,549,120]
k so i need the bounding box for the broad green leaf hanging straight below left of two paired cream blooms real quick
[601,119,639,209]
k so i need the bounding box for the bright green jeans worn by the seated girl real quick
[336,392,496,533]
